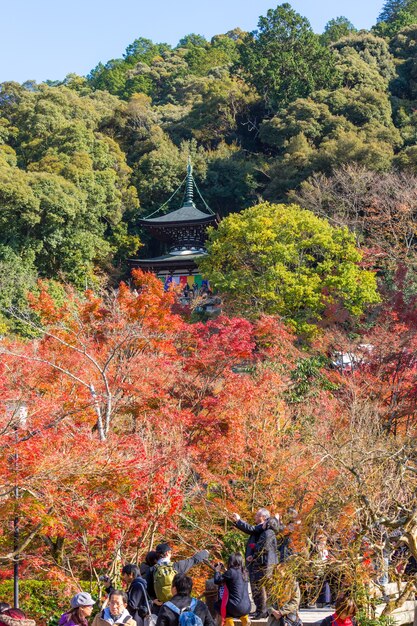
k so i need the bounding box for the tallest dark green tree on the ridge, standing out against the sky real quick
[238,3,339,110]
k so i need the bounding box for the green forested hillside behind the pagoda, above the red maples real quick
[0,0,417,303]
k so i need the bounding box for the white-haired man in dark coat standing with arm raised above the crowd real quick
[232,508,271,619]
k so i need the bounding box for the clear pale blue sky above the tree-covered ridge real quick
[0,0,383,82]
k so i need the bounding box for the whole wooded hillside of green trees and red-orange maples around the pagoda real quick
[0,0,417,624]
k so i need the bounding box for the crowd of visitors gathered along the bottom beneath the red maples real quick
[0,508,412,626]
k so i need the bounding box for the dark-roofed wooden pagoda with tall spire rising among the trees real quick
[129,158,219,287]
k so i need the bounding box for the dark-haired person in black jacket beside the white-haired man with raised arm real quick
[214,552,250,626]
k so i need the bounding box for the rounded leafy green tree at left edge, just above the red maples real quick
[0,155,106,285]
